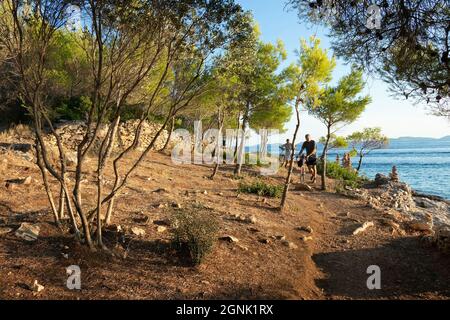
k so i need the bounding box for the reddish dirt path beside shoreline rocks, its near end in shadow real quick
[312,194,450,299]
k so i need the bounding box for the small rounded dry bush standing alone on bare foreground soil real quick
[172,206,219,265]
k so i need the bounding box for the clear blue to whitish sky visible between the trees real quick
[237,0,450,142]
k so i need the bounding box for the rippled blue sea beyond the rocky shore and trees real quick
[246,136,450,200]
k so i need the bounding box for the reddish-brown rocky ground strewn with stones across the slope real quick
[0,122,450,299]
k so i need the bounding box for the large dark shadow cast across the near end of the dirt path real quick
[312,237,450,299]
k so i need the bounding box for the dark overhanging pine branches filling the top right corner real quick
[288,0,450,116]
